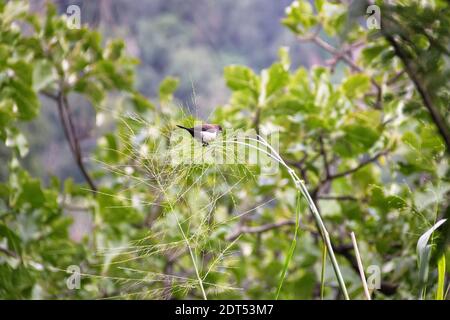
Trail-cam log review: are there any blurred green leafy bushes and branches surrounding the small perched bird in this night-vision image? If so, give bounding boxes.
[0,1,450,299]
